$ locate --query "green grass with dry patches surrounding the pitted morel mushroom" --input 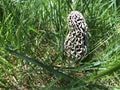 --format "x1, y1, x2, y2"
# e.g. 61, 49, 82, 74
0, 0, 120, 90
